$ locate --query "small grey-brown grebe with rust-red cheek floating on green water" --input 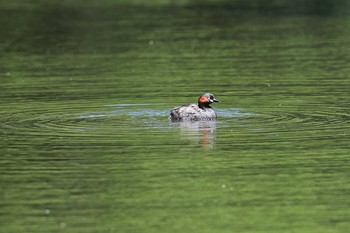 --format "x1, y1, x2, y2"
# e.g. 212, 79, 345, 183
169, 93, 220, 122
